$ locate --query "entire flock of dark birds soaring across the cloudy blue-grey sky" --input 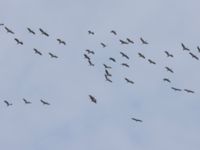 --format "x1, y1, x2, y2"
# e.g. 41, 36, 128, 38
0, 24, 200, 122
